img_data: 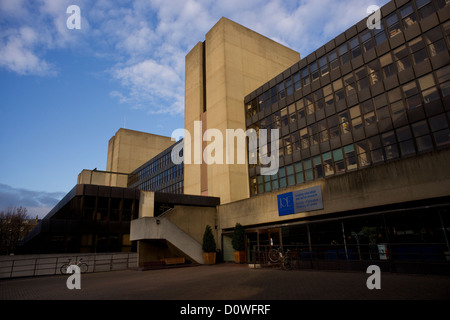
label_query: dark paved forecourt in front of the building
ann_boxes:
[0,264,450,301]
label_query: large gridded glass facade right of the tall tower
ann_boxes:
[245,0,450,195]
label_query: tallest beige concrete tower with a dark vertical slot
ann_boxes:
[184,18,300,203]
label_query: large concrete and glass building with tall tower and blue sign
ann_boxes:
[21,0,450,273]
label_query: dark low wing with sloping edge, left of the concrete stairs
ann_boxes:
[21,184,139,253]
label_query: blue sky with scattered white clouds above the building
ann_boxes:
[0,0,388,217]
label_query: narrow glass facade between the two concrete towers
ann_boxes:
[128,140,184,194]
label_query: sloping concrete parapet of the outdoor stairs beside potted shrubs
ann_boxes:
[130,217,204,264]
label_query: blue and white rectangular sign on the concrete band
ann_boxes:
[277,186,323,216]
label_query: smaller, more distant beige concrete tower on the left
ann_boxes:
[105,128,175,187]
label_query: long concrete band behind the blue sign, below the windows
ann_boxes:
[218,149,450,229]
